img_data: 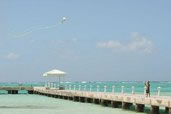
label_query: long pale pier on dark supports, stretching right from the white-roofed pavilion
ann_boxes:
[34,87,171,114]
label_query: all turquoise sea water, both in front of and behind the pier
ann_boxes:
[0,82,171,114]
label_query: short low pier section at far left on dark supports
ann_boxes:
[0,86,33,94]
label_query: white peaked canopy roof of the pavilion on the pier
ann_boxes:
[43,69,66,77]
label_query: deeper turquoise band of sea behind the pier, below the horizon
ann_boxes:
[0,81,171,96]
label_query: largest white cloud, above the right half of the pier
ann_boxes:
[97,32,153,53]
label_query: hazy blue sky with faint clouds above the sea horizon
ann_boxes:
[0,0,171,82]
